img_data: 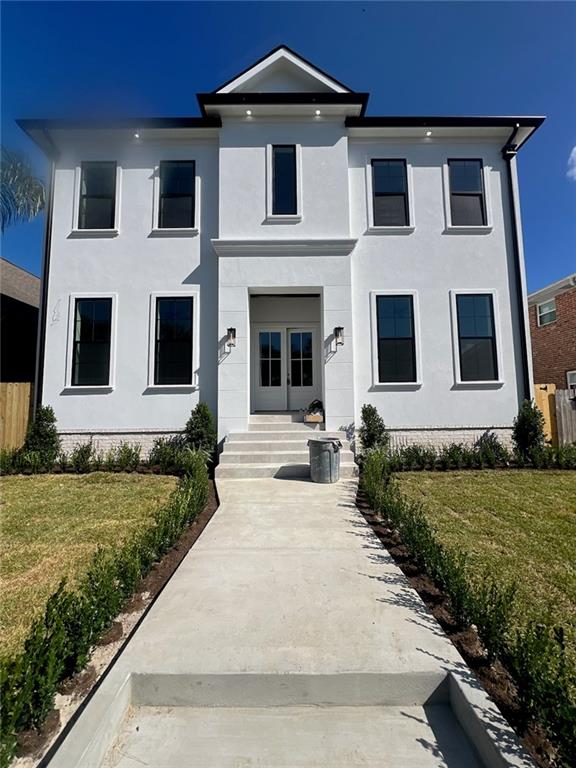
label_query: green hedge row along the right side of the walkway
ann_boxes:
[361,449,576,768]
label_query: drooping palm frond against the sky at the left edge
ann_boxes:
[0,146,46,232]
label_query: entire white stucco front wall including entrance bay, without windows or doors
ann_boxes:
[43,119,523,444]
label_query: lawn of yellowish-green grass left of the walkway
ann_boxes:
[0,472,177,656]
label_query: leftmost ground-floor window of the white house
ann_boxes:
[71,298,112,387]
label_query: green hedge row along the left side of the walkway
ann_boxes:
[0,453,209,768]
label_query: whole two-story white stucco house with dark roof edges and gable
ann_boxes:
[20,46,543,468]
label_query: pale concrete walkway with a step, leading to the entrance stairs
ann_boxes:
[51,479,532,768]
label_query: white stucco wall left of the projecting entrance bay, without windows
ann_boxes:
[43,140,218,443]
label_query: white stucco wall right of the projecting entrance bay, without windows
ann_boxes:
[350,139,523,442]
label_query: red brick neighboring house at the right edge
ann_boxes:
[528,274,576,389]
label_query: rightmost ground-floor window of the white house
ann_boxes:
[456,293,498,382]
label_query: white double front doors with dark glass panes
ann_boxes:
[252,326,321,411]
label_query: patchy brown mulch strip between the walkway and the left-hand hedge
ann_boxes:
[17,481,218,757]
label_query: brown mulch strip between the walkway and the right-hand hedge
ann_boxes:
[356,490,556,768]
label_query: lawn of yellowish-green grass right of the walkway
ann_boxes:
[396,470,576,622]
